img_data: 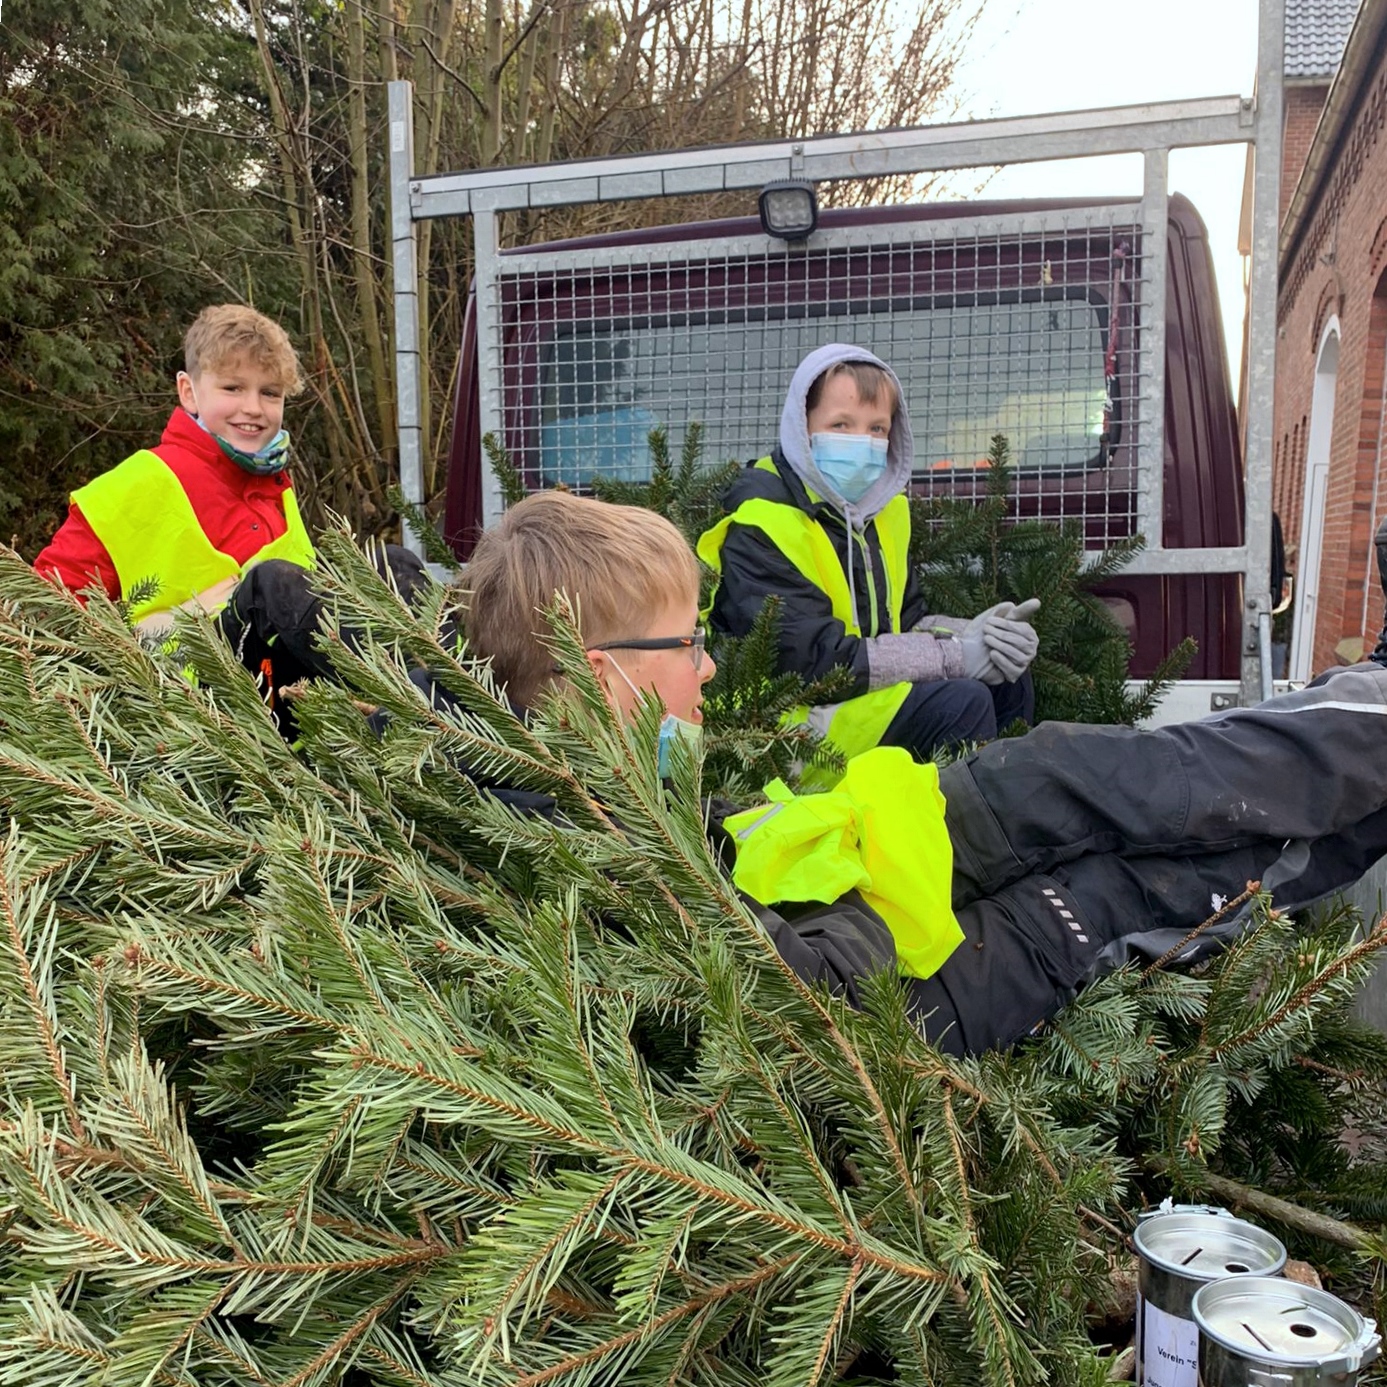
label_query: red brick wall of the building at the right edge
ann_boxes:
[1272,54,1387,669]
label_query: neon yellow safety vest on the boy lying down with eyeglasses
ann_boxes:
[723,746,963,978]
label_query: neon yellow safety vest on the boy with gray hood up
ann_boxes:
[698,458,911,756]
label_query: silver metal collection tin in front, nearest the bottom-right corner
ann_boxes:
[1193,1276,1381,1387]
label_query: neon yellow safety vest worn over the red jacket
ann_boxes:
[72,449,315,623]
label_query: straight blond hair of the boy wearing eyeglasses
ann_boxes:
[463,491,699,707]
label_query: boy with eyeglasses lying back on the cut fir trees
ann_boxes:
[454,492,1387,1054]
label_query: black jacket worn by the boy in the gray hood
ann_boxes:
[709,448,925,694]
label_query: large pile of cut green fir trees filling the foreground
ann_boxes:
[0,507,1387,1387]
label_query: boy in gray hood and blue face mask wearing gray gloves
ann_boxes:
[698,343,1039,760]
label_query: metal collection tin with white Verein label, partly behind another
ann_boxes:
[1133,1200,1286,1387]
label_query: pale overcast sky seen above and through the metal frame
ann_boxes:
[957,0,1257,390]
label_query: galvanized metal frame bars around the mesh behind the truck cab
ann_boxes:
[390,0,1284,703]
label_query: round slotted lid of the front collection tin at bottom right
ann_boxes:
[1194,1276,1381,1372]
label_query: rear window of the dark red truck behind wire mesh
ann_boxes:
[528,284,1108,487]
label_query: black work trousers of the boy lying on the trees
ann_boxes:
[907,664,1387,1053]
